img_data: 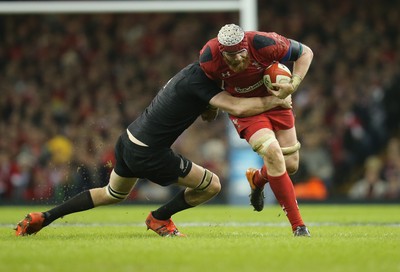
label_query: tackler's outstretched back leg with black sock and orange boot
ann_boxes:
[15,170,137,236]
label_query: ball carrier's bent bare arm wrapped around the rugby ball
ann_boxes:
[272,40,314,98]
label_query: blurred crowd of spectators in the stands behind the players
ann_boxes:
[0,0,400,205]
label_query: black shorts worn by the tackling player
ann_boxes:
[114,131,192,186]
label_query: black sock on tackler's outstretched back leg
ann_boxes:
[43,191,94,226]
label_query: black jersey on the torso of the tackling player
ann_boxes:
[128,62,222,148]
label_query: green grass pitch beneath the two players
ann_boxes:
[0,205,400,272]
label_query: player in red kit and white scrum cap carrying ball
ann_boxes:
[199,24,313,236]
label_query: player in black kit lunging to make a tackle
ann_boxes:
[15,63,291,236]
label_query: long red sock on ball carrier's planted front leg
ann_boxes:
[268,172,304,230]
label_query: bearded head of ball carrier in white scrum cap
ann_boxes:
[217,24,250,72]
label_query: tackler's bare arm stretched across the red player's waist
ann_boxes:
[209,91,292,117]
